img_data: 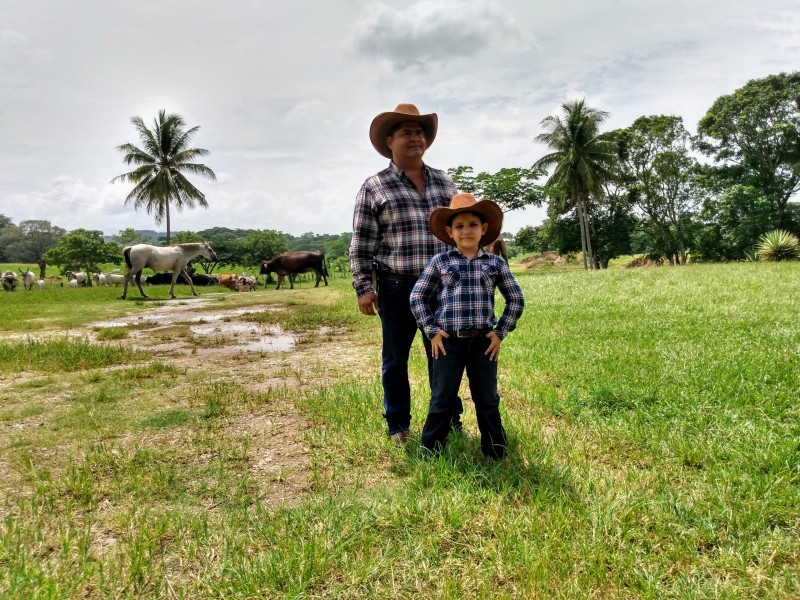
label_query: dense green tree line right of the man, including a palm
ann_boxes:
[500,72,800,268]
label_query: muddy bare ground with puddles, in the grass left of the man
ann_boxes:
[86,300,366,505]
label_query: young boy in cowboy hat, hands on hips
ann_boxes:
[410,194,525,459]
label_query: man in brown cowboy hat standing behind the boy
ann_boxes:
[350,104,463,444]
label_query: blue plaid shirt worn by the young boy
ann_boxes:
[410,248,525,339]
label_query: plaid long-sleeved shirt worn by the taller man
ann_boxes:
[350,163,457,296]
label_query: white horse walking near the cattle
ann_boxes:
[120,242,218,300]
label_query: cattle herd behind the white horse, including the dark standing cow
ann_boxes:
[0,251,328,292]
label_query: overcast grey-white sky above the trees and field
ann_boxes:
[0,0,800,235]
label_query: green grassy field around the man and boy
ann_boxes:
[0,263,800,599]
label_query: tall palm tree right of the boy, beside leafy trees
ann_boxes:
[531,100,617,269]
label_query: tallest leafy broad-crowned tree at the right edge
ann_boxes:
[697,71,800,225]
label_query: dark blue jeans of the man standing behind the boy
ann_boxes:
[378,280,464,435]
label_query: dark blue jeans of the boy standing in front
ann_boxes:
[422,335,506,458]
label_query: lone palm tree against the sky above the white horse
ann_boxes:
[111,109,217,246]
